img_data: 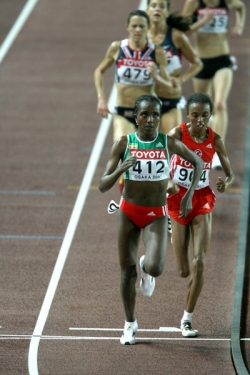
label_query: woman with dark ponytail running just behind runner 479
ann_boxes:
[147,0,206,134]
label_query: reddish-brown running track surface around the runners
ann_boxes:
[0,0,250,375]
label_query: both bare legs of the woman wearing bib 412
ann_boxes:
[117,210,167,322]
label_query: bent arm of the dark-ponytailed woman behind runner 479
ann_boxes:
[173,29,203,83]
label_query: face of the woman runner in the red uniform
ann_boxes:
[187,103,212,132]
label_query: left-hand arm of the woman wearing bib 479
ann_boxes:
[94,42,120,118]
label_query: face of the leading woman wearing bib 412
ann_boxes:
[135,101,161,138]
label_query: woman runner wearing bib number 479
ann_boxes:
[94,10,176,193]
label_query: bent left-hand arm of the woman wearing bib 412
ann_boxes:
[99,135,136,193]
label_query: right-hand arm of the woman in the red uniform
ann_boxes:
[214,133,235,193]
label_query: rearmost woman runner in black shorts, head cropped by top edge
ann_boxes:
[183,0,246,169]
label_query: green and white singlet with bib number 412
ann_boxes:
[123,132,170,181]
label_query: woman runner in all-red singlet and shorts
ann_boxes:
[167,93,234,337]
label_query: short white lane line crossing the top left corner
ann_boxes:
[0,0,38,64]
